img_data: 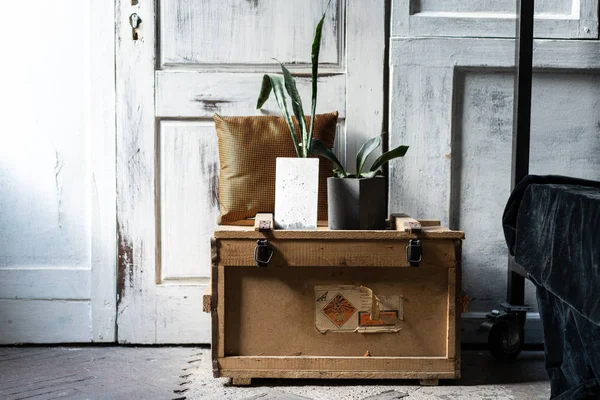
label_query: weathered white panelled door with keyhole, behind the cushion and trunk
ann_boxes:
[116,0,386,343]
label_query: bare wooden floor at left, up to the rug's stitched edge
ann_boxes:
[0,347,201,400]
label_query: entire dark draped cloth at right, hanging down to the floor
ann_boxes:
[502,175,600,399]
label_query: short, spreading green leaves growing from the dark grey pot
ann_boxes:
[311,136,408,178]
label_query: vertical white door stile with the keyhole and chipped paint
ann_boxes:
[115,0,159,343]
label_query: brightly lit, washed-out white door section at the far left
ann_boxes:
[0,0,115,343]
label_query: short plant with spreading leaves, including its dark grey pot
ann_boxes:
[311,136,408,229]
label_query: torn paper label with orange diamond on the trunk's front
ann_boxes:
[315,285,404,333]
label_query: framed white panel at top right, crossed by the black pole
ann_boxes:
[392,0,598,39]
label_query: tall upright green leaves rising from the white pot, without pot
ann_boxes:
[256,0,331,158]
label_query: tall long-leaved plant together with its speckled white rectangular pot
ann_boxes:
[256,1,331,229]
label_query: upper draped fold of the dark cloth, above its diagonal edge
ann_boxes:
[502,175,600,325]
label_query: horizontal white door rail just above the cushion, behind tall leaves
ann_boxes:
[156,71,346,119]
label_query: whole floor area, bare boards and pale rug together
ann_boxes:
[0,346,550,400]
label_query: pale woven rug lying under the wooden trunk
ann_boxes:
[183,349,550,400]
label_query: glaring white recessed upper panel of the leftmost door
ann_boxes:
[0,1,90,267]
